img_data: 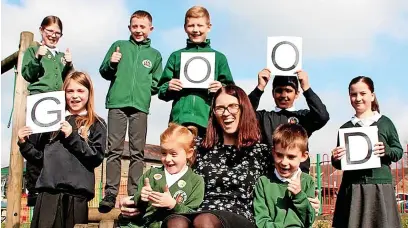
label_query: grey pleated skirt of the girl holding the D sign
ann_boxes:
[333,184,401,228]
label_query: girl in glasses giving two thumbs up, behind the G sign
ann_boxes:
[21,16,73,206]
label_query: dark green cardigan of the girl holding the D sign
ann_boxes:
[332,115,403,185]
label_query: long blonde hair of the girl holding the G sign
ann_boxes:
[62,71,99,141]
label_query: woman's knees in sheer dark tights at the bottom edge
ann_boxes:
[166,213,222,228]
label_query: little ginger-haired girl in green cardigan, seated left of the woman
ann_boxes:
[119,123,204,227]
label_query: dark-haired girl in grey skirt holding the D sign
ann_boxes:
[332,76,403,228]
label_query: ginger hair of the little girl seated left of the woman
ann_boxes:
[160,123,198,165]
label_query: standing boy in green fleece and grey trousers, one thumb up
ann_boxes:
[99,10,162,213]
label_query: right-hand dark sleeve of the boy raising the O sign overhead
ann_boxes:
[302,88,330,134]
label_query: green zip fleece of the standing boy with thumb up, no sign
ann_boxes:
[99,37,162,113]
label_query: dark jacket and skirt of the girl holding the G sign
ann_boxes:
[18,115,106,228]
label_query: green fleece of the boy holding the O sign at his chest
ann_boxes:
[158,39,234,128]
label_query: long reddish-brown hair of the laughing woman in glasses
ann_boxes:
[202,85,261,149]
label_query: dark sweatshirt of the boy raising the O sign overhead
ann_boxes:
[248,87,330,173]
